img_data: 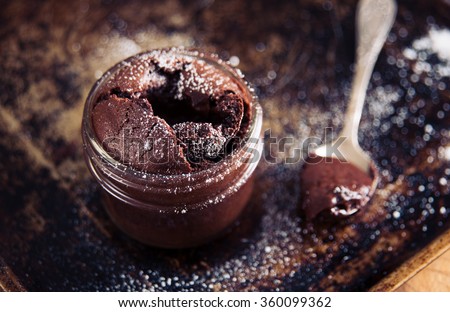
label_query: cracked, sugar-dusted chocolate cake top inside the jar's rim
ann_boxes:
[92,50,250,175]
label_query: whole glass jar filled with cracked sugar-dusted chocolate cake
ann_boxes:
[82,48,262,248]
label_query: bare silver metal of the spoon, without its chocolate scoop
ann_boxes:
[314,0,397,173]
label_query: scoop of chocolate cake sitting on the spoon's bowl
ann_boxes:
[300,156,376,220]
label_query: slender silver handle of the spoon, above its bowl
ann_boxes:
[341,0,397,143]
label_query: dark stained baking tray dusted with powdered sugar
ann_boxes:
[0,0,450,291]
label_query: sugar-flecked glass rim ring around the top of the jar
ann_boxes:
[82,47,262,187]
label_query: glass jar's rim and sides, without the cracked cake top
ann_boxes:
[82,49,262,248]
